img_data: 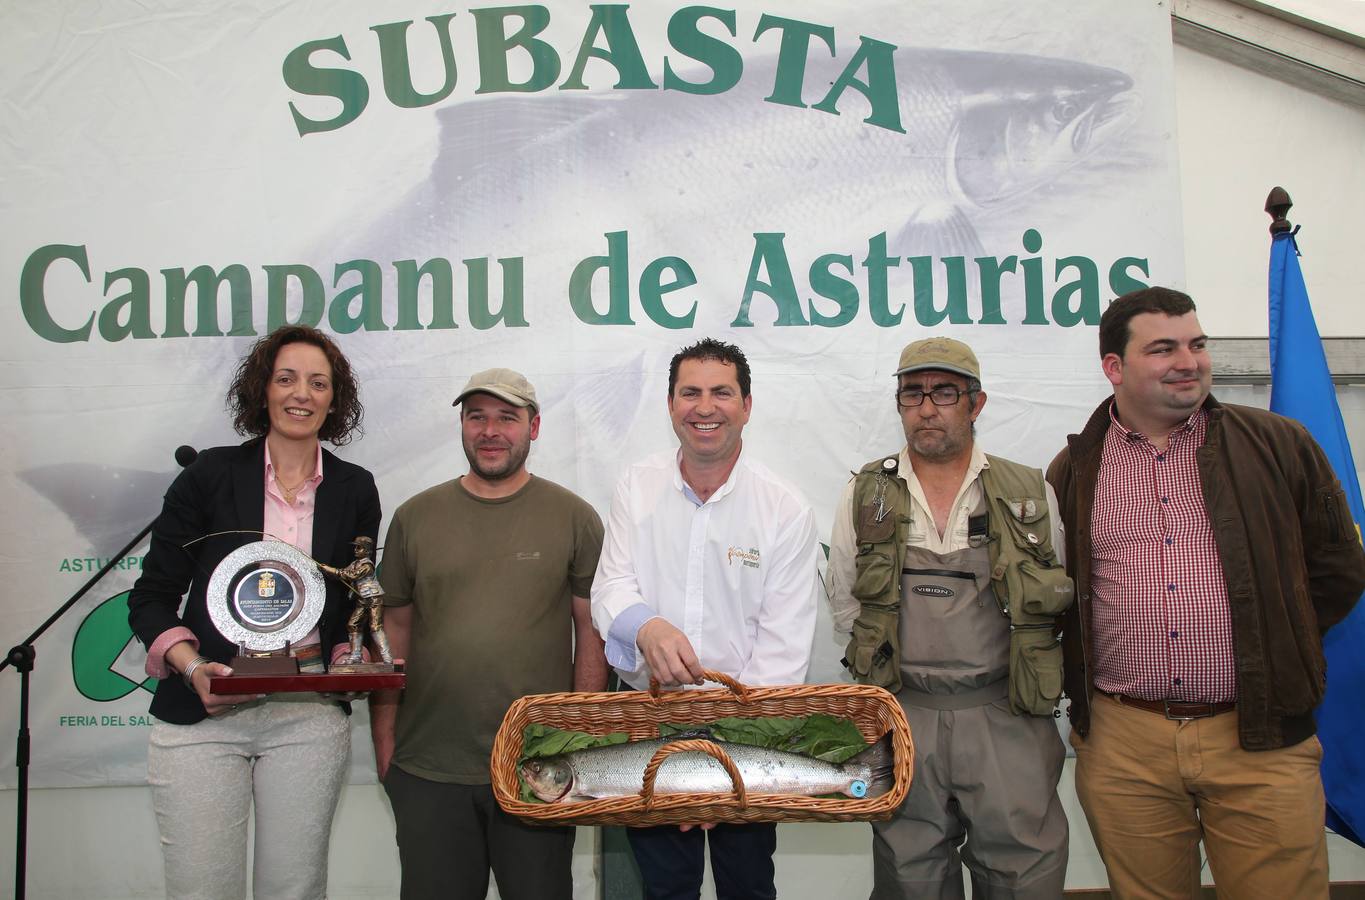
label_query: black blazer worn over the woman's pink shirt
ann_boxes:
[128,438,381,725]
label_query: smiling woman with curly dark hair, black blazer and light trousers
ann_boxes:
[128,325,381,900]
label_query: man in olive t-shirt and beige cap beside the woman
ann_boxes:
[370,369,606,900]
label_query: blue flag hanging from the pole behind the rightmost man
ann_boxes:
[1269,228,1365,847]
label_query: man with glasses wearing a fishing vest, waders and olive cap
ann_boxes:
[829,337,1073,900]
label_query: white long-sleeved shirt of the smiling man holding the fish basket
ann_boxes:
[592,449,819,690]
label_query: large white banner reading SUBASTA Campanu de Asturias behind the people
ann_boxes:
[0,0,1183,785]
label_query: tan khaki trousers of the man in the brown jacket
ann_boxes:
[1072,691,1327,900]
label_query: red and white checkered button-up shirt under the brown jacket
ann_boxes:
[1091,406,1237,703]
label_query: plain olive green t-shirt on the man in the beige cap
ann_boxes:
[379,475,602,784]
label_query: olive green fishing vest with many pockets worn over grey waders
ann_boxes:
[844,456,1074,716]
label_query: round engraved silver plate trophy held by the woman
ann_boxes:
[206,541,328,675]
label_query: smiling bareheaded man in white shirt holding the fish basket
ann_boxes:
[592,339,818,900]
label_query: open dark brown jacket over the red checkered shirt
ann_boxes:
[1047,396,1365,750]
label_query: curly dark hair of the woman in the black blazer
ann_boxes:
[228,325,364,447]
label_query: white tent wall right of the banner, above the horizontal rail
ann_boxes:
[1175,37,1365,337]
